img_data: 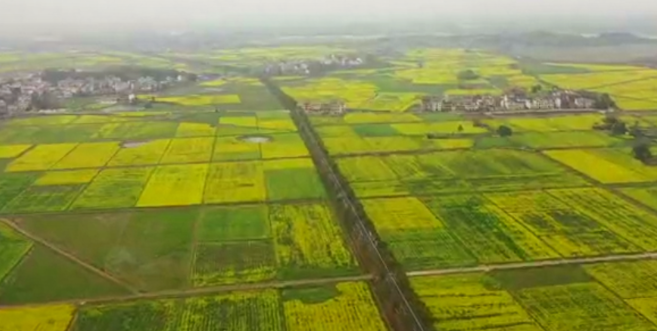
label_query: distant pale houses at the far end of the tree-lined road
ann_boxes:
[263,54,365,76]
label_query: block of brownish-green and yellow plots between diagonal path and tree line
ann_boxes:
[11,202,359,296]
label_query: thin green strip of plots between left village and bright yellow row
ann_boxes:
[0,111,296,145]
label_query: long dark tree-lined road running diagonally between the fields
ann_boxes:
[261,78,435,331]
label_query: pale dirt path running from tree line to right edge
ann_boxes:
[406,253,657,277]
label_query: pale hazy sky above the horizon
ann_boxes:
[0,0,657,27]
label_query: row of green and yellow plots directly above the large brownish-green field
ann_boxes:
[0,159,324,212]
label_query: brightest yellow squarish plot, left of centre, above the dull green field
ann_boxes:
[137,164,208,207]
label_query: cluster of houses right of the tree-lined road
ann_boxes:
[421,89,596,112]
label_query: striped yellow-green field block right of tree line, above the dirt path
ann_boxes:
[362,188,657,269]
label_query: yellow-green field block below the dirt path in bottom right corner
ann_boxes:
[411,261,657,331]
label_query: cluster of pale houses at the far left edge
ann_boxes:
[0,73,184,115]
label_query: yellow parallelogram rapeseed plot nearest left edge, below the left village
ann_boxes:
[6,144,77,171]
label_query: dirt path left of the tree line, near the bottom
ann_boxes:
[0,275,372,309]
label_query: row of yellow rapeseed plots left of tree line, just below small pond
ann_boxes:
[2,133,308,172]
